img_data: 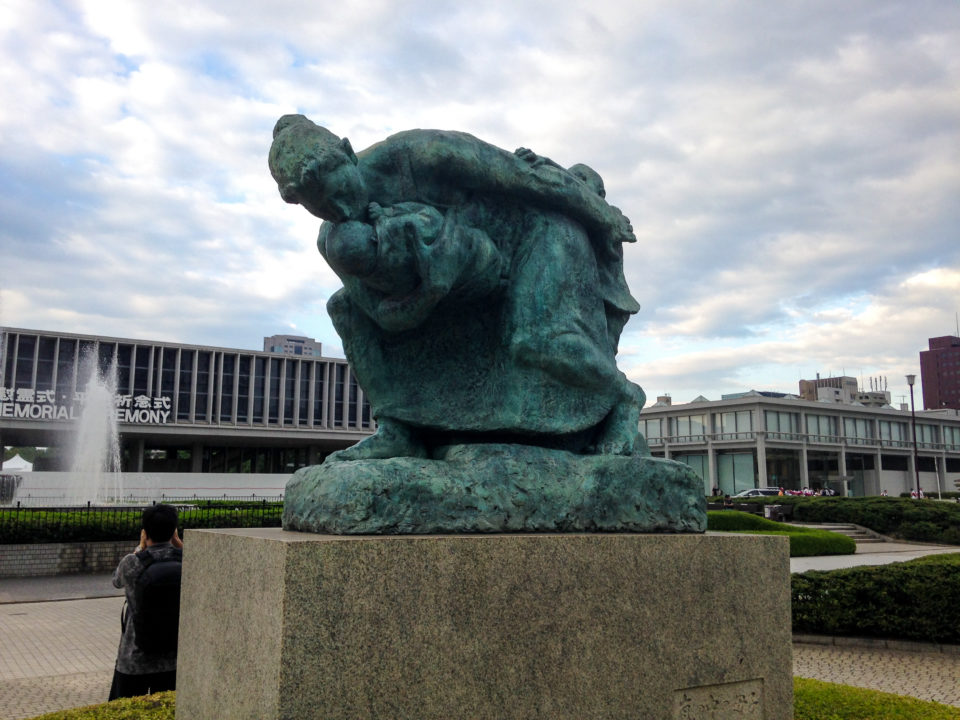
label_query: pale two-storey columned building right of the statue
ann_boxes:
[640,393,960,496]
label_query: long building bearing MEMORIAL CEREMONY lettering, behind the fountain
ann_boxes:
[0,327,375,500]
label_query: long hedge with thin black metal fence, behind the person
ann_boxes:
[0,496,283,544]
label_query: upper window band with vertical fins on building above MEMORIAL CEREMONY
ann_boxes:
[0,333,372,428]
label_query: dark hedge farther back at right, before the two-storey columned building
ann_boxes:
[728,496,960,545]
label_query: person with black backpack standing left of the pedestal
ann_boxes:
[109,504,183,700]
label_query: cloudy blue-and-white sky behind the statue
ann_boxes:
[0,0,960,402]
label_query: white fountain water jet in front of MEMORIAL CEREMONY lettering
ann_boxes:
[65,352,123,505]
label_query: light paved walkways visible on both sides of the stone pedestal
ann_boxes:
[0,543,960,720]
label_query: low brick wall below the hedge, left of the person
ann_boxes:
[0,540,136,578]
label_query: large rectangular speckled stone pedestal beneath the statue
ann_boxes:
[177,530,793,720]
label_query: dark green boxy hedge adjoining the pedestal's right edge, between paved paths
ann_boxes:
[791,553,960,644]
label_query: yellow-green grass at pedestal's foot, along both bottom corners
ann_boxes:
[24,678,960,720]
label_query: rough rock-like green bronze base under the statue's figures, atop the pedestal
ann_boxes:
[283,444,706,535]
